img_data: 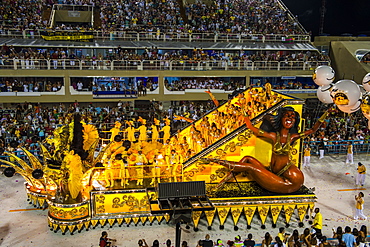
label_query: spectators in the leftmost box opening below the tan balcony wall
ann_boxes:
[0,77,64,92]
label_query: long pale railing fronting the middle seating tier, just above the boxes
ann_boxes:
[0,58,330,71]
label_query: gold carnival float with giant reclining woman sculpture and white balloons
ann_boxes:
[0,66,370,234]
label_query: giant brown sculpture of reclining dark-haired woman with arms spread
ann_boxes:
[203,107,329,193]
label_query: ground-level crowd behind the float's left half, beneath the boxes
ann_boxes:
[0,101,213,151]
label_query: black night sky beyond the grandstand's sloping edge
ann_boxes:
[282,0,370,36]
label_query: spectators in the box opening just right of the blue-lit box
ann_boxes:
[164,77,245,91]
